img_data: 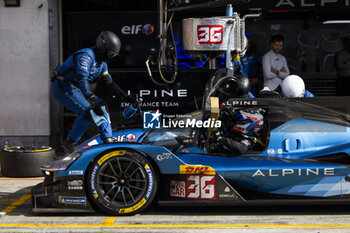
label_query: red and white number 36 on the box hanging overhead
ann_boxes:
[197,25,223,44]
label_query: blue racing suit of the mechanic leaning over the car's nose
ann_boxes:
[52,47,113,141]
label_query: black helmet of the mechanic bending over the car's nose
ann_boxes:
[96,31,121,60]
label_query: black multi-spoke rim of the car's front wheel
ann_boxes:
[96,157,148,208]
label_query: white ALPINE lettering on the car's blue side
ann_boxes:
[252,168,335,177]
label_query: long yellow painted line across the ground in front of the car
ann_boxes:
[0,224,350,228]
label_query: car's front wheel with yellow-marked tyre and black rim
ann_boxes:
[87,149,158,215]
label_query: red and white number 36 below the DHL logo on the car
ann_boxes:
[186,175,215,200]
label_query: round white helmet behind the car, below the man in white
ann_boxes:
[281,75,305,98]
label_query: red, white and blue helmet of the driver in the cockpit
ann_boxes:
[232,108,264,135]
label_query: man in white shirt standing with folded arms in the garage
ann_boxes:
[262,35,289,91]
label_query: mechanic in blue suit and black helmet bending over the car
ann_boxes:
[50,31,136,152]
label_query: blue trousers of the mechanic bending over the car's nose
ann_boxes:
[52,80,112,142]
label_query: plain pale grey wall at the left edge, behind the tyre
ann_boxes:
[0,0,59,148]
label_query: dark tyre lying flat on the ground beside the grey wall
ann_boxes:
[0,146,55,178]
